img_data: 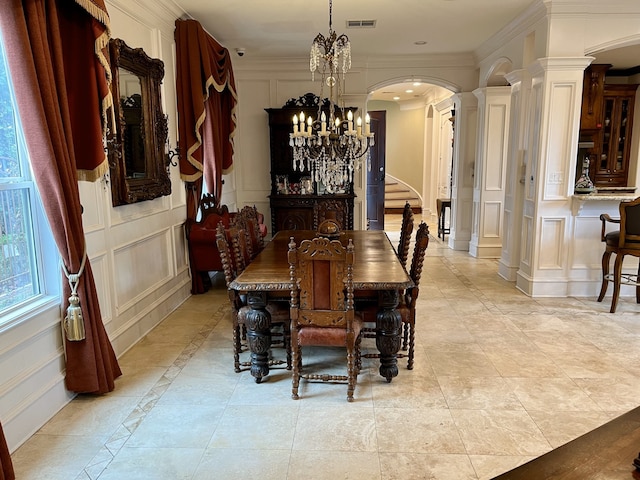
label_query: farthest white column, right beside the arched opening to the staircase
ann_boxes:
[448,92,478,251]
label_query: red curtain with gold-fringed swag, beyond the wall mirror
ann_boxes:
[175,20,237,219]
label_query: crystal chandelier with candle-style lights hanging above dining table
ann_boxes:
[289,0,374,193]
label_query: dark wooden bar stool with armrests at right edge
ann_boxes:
[598,197,640,313]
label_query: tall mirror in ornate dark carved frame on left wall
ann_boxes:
[107,38,171,206]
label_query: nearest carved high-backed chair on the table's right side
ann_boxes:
[358,222,429,370]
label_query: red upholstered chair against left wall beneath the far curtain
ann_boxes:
[185,202,231,294]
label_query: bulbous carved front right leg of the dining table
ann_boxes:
[376,290,402,382]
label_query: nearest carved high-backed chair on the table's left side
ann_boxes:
[216,224,291,373]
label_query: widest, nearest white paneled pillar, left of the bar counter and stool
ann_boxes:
[516,57,592,297]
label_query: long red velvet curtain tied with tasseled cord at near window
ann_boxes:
[0,0,122,402]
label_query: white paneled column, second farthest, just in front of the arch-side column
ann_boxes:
[469,87,511,258]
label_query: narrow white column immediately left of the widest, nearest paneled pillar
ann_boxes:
[498,70,531,281]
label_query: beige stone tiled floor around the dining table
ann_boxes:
[8,216,640,480]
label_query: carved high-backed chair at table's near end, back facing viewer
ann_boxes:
[288,237,362,402]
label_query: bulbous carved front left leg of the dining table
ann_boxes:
[246,292,271,383]
